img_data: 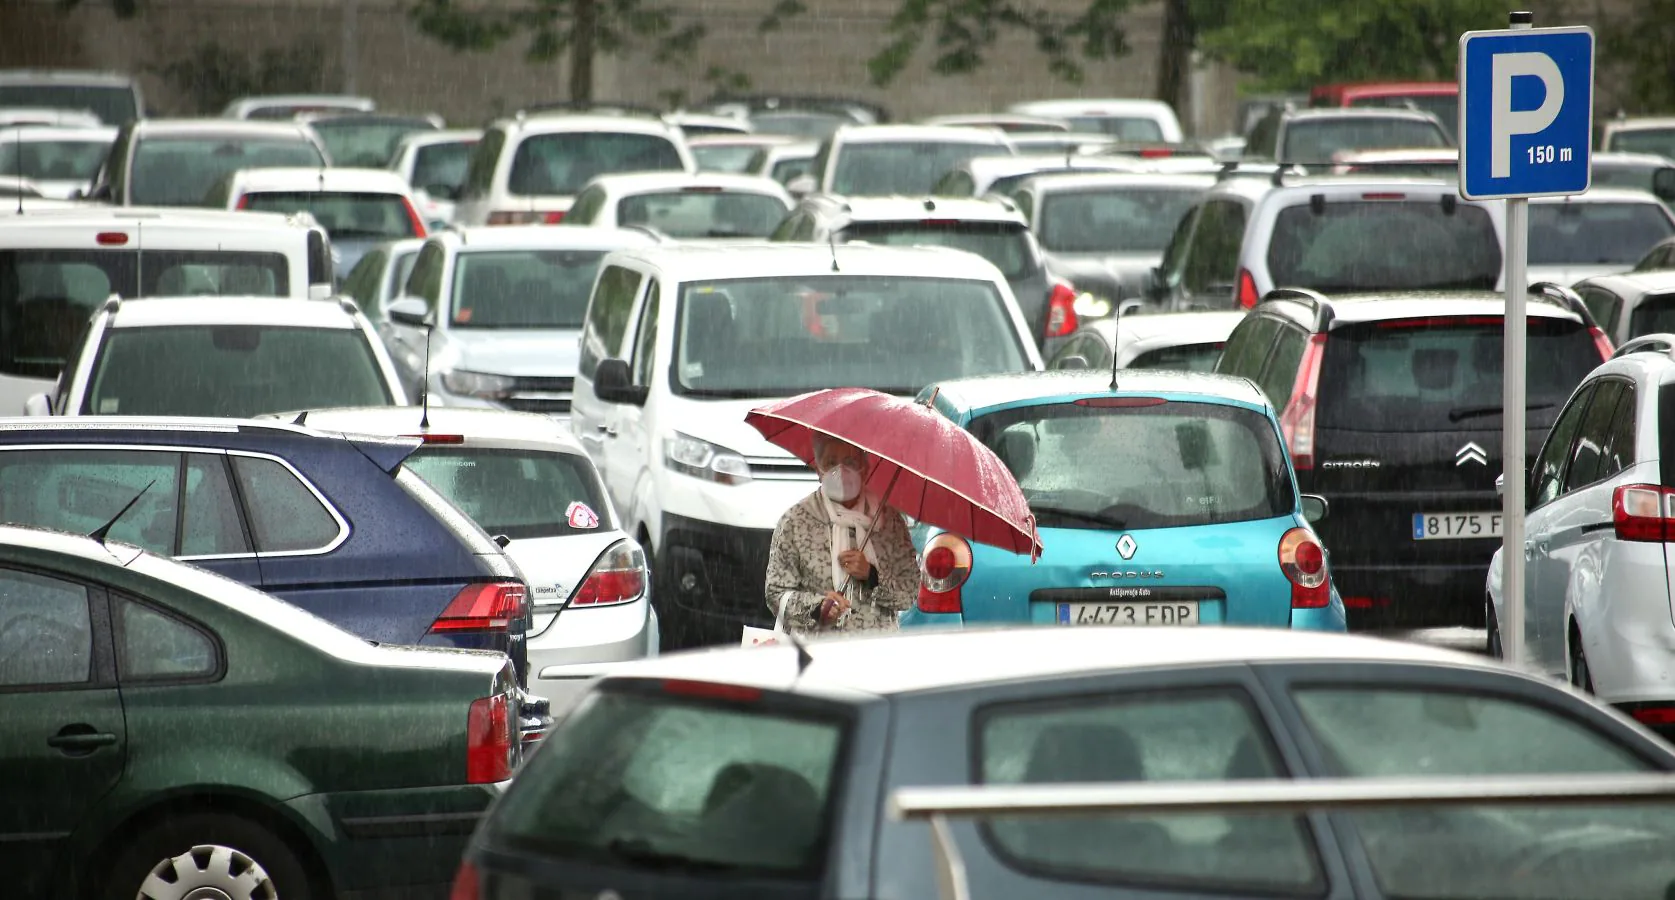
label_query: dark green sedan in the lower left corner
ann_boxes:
[0,528,518,900]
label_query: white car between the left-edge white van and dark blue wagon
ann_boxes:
[23,297,407,419]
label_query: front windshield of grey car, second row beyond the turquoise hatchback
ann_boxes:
[1035,188,1203,253]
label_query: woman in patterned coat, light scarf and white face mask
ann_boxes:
[765,432,920,632]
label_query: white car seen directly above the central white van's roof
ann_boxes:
[561,173,791,240]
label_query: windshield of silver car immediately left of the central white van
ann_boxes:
[452,250,605,328]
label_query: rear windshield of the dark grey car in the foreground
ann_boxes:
[484,689,846,880]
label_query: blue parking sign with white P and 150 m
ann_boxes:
[1459,27,1593,199]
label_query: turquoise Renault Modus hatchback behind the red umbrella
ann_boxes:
[901,370,1345,632]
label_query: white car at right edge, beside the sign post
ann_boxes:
[1487,334,1675,737]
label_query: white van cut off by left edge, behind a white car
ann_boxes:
[0,206,332,412]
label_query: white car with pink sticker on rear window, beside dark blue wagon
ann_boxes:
[261,406,658,709]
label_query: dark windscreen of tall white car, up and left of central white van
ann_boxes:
[506,131,685,196]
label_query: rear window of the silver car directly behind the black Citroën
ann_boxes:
[1268,201,1507,292]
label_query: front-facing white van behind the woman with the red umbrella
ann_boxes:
[571,243,1042,650]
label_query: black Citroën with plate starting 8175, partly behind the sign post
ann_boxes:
[1216,285,1611,628]
